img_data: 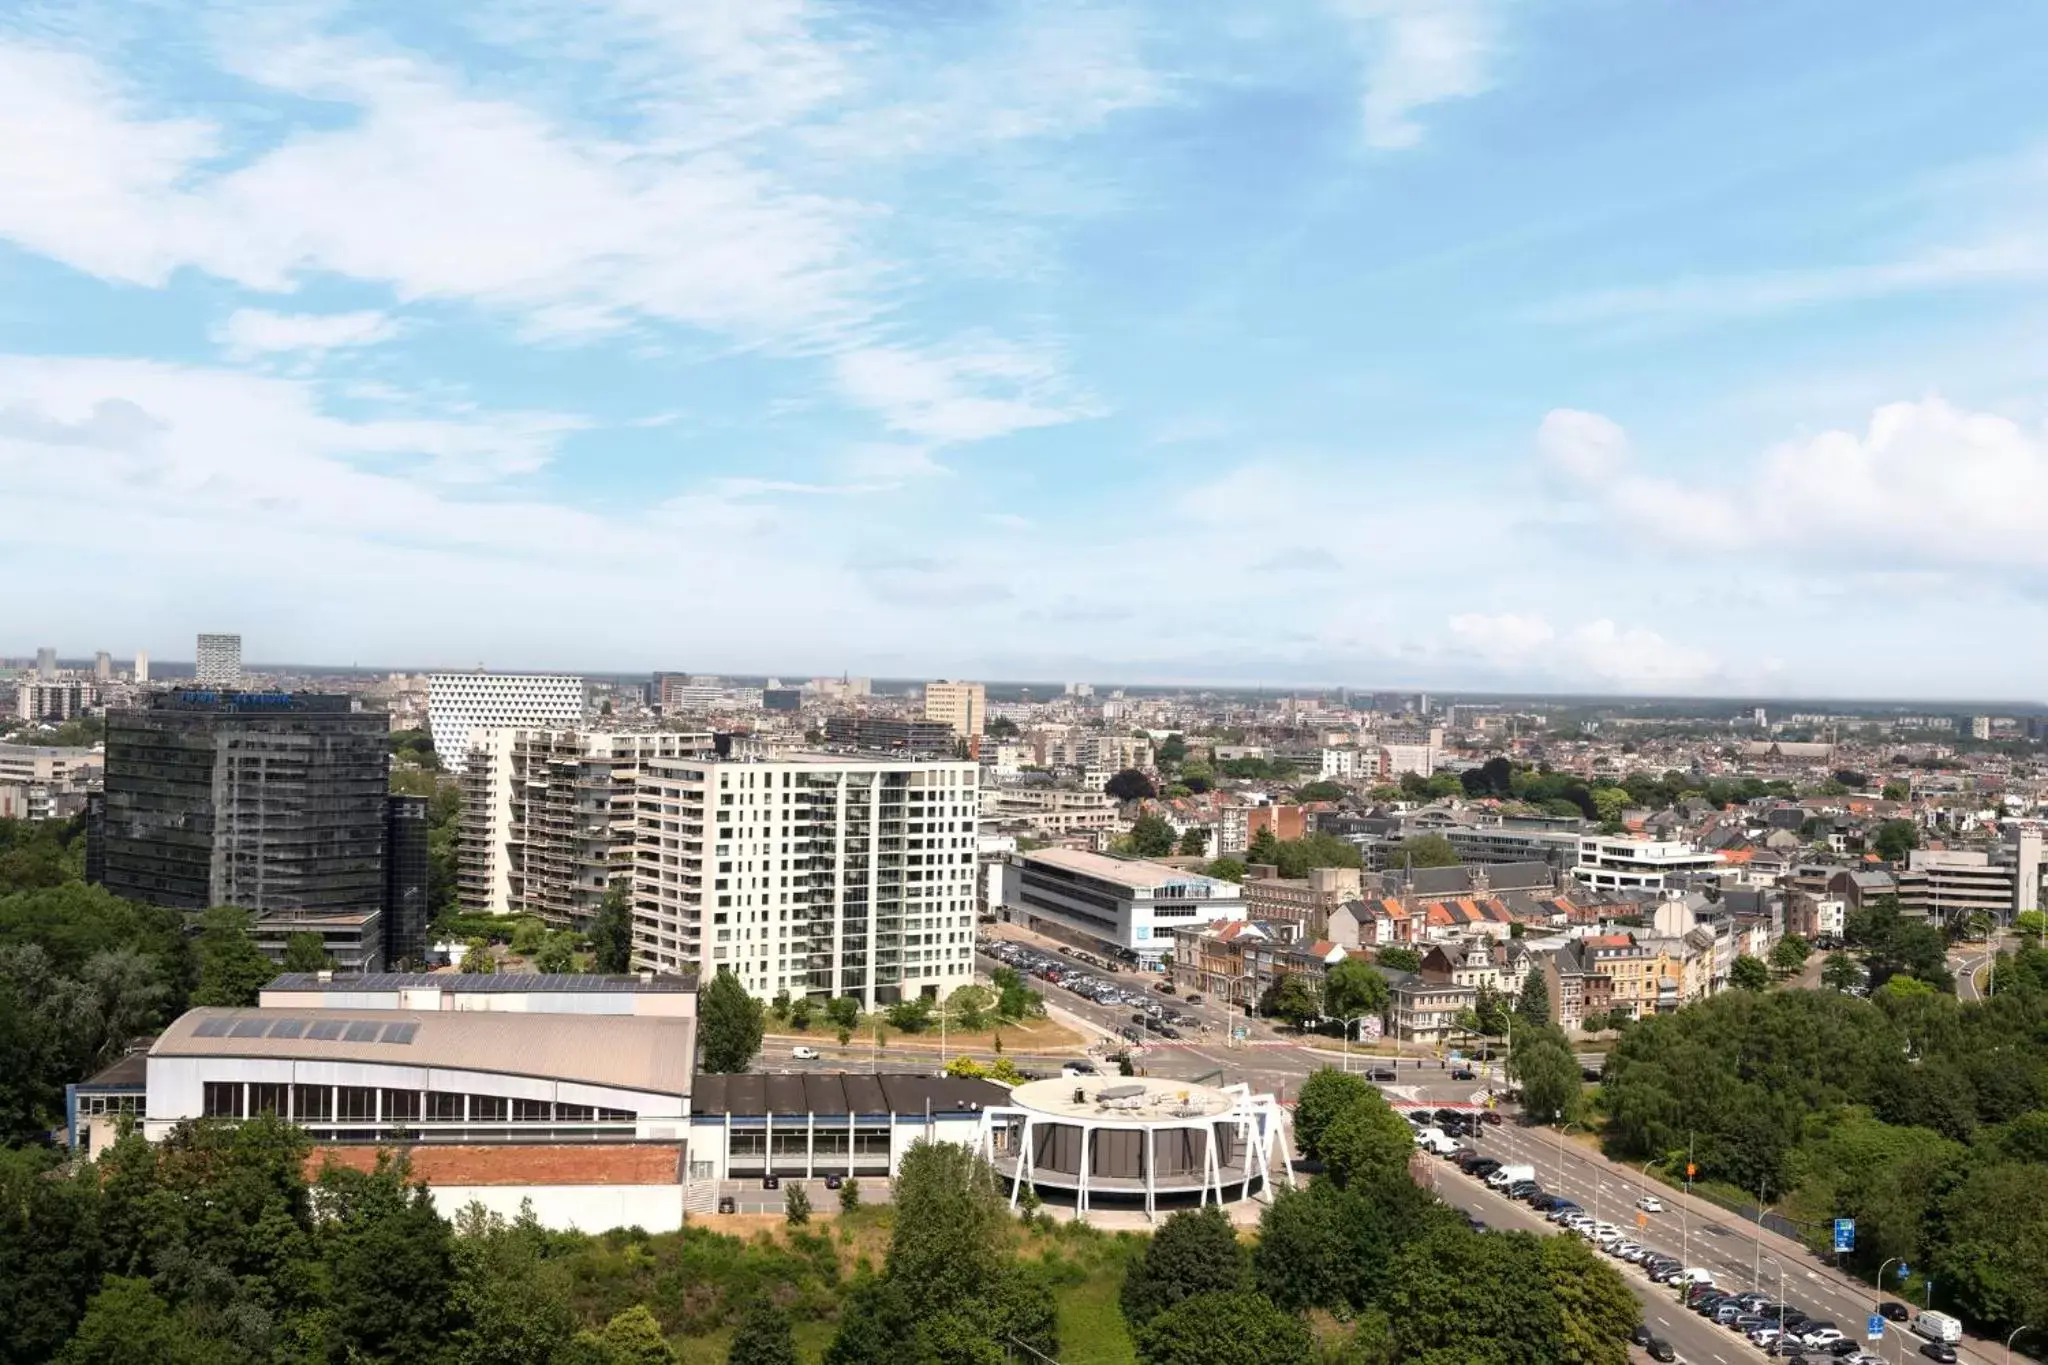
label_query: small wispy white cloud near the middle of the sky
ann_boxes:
[834,338,1100,442]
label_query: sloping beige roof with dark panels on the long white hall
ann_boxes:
[150,1007,696,1095]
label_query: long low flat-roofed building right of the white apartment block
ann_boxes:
[1001,849,1245,962]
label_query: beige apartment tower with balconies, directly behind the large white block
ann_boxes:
[455,729,713,929]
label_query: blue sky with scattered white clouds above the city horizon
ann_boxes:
[0,0,2048,700]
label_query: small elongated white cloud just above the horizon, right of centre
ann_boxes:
[1446,612,1720,690]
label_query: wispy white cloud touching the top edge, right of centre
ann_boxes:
[1331,0,1495,149]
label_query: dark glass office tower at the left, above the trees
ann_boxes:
[100,690,389,915]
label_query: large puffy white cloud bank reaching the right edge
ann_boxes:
[1538,397,2048,569]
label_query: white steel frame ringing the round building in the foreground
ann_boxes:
[981,1085,1294,1222]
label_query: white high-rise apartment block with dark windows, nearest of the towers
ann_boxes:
[633,755,979,1009]
